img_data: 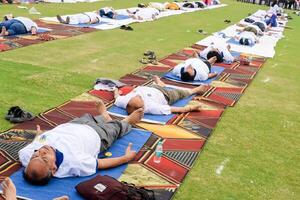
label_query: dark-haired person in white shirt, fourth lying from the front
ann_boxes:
[199,42,235,63]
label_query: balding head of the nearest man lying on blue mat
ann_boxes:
[23,145,57,185]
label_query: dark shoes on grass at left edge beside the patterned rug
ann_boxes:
[5,106,34,123]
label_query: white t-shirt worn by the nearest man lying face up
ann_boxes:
[19,123,101,178]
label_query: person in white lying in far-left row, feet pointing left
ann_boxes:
[56,12,101,25]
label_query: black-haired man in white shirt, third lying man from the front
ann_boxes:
[172,56,218,82]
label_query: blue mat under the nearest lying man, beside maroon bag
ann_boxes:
[11,129,151,200]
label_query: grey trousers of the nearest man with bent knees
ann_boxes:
[70,114,132,152]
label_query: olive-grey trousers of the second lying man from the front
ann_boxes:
[150,85,191,105]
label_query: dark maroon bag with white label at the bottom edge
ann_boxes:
[75,175,155,200]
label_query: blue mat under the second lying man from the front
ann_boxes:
[108,96,194,124]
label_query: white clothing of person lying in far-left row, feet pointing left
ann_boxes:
[69,12,101,25]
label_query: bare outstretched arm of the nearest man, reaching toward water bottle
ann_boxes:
[97,143,136,169]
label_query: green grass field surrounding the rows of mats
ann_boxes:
[0,0,300,200]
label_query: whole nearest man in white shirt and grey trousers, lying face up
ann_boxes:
[19,101,143,185]
